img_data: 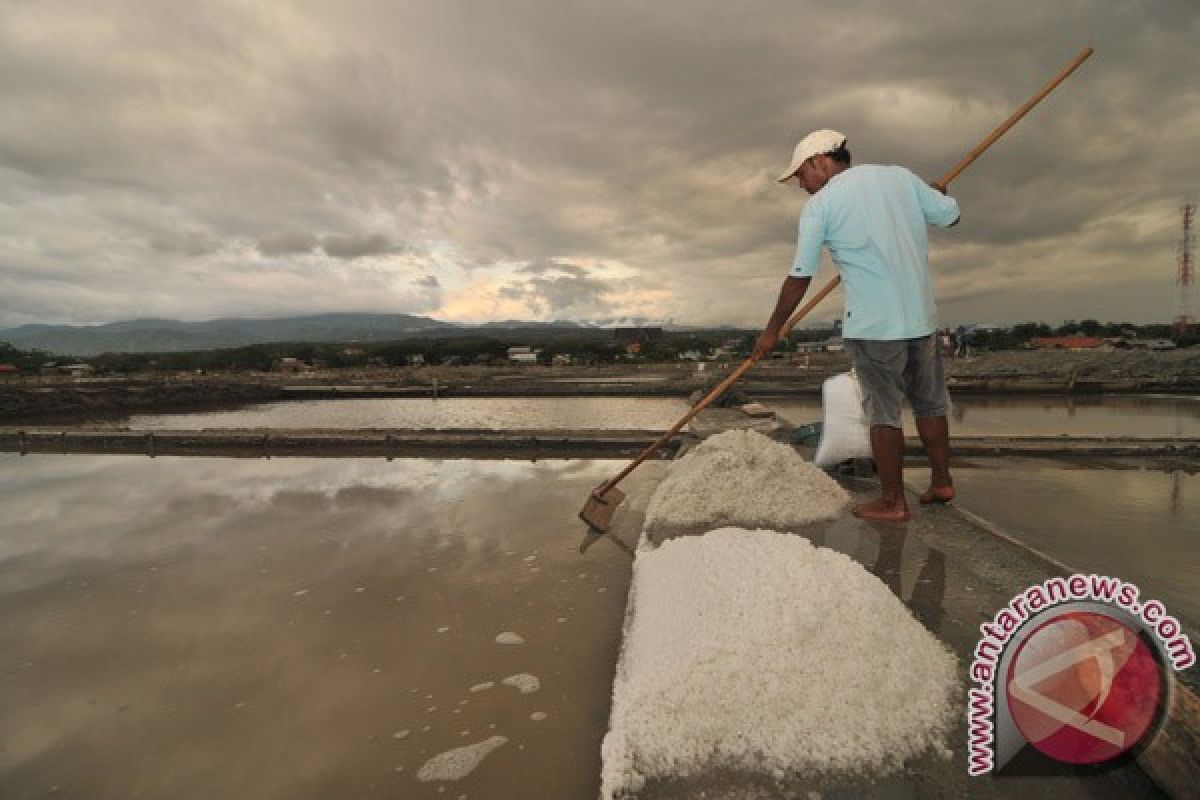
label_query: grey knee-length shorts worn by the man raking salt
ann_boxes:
[845,333,950,428]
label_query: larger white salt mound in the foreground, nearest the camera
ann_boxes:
[601,528,958,798]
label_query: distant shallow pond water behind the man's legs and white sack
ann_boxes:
[764,395,1200,437]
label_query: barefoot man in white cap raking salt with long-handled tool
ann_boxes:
[755,130,959,522]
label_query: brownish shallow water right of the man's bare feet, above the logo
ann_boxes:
[905,458,1200,624]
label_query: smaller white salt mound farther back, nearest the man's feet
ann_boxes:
[646,431,850,529]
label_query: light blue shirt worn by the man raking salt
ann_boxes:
[790,164,959,339]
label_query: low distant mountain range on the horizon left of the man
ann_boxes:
[0,313,705,356]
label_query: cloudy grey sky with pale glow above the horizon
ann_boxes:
[0,0,1200,326]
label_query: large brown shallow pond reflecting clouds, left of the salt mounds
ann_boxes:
[0,456,661,800]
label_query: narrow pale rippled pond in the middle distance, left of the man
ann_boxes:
[128,397,688,431]
